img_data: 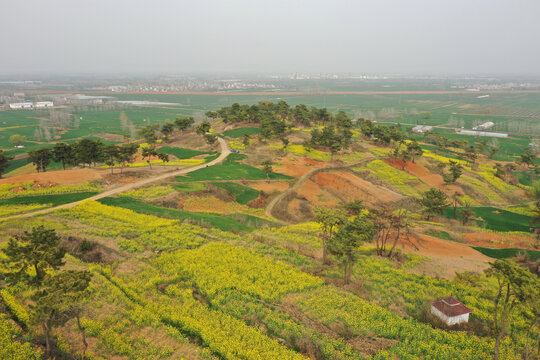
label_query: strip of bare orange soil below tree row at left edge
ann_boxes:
[0,169,108,185]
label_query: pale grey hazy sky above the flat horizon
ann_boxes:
[0,0,540,75]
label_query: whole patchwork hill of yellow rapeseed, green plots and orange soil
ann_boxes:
[0,102,540,359]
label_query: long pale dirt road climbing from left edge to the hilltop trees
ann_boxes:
[0,137,231,221]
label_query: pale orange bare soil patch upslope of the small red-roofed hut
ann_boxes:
[398,233,492,279]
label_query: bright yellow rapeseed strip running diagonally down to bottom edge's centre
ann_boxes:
[92,264,306,360]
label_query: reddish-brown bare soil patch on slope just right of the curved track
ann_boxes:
[314,170,402,206]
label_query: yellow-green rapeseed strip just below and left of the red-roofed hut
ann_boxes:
[295,287,517,360]
